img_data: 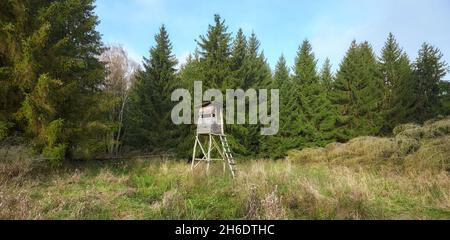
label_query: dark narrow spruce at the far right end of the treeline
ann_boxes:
[414,43,448,122]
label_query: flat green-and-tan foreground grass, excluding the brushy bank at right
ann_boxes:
[0,157,450,219]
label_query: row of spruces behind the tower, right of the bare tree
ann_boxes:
[128,15,450,158]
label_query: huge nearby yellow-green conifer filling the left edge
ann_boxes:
[0,0,108,164]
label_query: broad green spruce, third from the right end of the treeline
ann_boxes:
[331,41,383,141]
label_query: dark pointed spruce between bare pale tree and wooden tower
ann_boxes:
[126,25,177,151]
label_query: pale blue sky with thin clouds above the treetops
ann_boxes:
[95,0,450,76]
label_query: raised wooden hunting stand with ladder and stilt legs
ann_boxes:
[191,102,236,178]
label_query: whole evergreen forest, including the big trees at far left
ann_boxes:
[0,0,450,165]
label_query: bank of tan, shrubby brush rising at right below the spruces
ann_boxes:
[288,118,450,171]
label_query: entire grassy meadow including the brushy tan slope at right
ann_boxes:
[0,119,450,219]
